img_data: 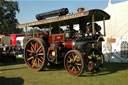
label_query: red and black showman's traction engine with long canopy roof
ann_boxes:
[17,8,110,76]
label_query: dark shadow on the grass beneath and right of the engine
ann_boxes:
[44,62,128,77]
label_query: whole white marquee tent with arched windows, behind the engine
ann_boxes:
[102,0,128,63]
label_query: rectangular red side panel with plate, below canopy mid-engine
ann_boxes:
[48,34,64,43]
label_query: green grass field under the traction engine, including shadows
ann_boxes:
[0,58,128,85]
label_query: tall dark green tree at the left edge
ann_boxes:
[0,0,23,35]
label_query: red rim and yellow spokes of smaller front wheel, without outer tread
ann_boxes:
[65,52,83,76]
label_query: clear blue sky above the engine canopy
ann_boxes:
[12,0,127,24]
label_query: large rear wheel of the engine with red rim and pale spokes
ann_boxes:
[25,39,45,71]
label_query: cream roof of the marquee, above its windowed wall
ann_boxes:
[104,0,128,37]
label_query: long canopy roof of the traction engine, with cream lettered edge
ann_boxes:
[16,9,110,28]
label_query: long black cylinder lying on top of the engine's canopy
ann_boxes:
[36,8,69,20]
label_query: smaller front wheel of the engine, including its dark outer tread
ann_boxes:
[64,50,85,76]
